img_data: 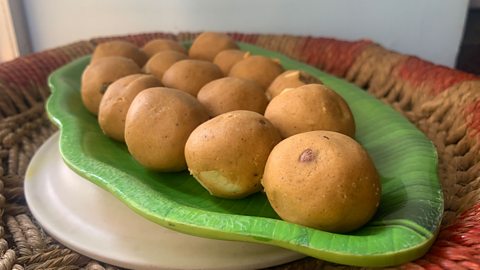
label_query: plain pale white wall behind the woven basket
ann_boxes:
[23,0,469,66]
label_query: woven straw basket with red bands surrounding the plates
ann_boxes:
[0,33,480,270]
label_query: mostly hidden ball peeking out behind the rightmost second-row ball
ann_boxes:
[265,70,322,100]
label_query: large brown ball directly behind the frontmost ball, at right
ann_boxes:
[265,84,355,138]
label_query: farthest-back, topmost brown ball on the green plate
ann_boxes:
[188,32,238,61]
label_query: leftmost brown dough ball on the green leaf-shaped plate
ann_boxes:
[80,56,142,115]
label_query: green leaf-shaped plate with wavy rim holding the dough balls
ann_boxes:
[47,44,443,266]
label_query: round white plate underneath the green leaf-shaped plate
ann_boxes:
[25,133,305,269]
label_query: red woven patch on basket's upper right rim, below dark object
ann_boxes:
[394,57,476,95]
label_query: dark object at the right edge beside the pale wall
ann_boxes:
[456,9,480,75]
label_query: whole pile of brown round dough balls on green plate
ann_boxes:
[81,32,381,232]
